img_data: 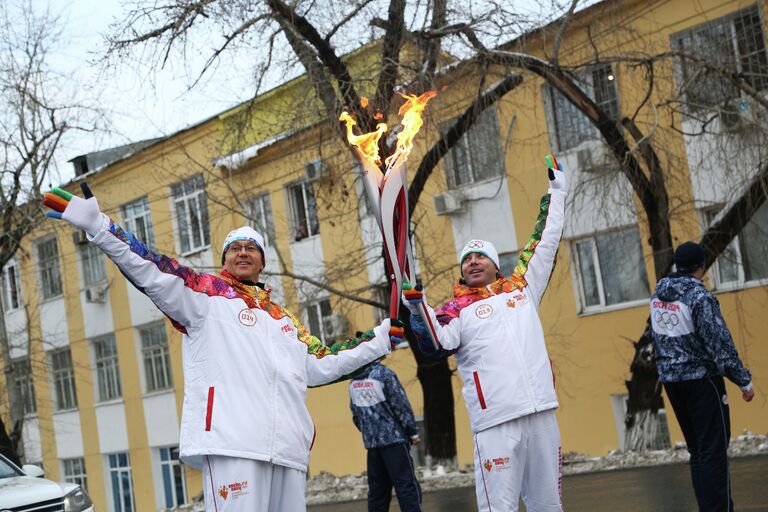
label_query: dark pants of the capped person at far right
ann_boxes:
[664,377,733,512]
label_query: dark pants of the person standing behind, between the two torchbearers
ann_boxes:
[368,443,421,512]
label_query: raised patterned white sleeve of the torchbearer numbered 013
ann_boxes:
[510,190,566,307]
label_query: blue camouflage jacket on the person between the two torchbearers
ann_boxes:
[349,363,419,449]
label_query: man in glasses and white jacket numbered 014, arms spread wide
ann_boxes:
[44,184,390,512]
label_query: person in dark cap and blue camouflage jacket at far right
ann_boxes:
[650,242,755,512]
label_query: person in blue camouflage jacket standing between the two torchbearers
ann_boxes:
[349,361,421,512]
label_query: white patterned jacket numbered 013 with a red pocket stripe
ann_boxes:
[411,190,566,433]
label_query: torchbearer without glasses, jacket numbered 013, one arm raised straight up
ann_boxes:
[404,165,566,512]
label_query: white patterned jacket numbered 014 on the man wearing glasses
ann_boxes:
[92,216,390,471]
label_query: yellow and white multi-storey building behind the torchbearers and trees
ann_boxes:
[0,0,768,512]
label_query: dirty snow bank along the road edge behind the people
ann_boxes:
[167,430,768,512]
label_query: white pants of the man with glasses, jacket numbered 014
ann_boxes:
[203,455,307,512]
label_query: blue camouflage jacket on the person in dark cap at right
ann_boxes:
[650,274,752,388]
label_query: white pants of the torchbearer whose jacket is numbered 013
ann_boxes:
[475,409,563,512]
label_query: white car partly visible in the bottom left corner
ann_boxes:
[0,455,94,512]
